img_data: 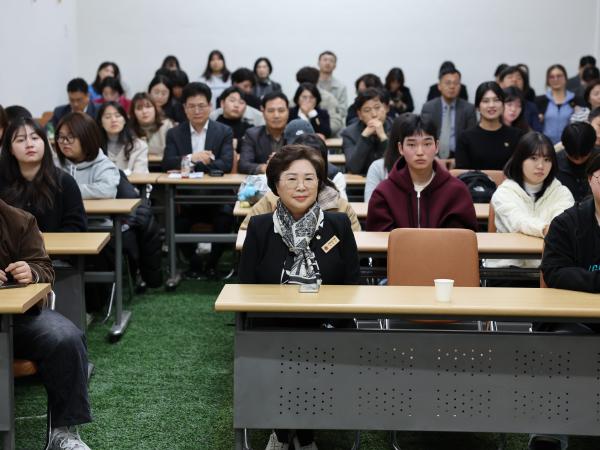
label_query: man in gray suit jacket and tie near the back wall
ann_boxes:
[421,68,477,159]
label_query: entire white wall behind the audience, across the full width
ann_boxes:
[0,0,600,116]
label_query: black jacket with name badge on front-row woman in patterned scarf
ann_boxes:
[239,212,360,284]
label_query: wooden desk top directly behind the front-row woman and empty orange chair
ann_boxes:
[235,230,544,256]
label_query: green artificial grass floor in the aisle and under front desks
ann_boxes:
[15,281,600,450]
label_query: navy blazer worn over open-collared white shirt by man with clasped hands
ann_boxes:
[162,120,233,173]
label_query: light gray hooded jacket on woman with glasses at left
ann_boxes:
[61,150,120,200]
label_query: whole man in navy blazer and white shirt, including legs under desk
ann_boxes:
[162,82,233,278]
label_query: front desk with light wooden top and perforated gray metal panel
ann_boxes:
[216,285,600,440]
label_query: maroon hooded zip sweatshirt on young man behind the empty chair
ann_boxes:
[366,158,477,231]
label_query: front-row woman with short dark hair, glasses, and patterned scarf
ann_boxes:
[239,145,359,450]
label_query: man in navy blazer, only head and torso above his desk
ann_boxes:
[162,82,233,173]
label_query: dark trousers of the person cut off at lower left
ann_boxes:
[13,309,92,427]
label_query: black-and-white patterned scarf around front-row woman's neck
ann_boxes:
[273,200,324,285]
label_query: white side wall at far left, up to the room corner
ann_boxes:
[0,0,77,116]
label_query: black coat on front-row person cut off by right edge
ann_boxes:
[541,198,600,292]
